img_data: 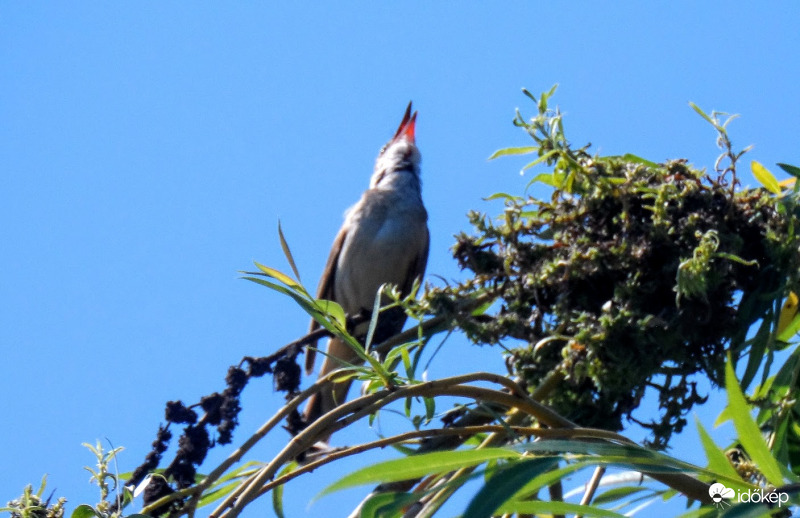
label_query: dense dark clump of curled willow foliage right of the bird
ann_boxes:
[446,87,800,448]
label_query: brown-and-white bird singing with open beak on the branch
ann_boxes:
[304,103,430,432]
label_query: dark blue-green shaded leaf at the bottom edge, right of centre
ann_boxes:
[463,457,559,518]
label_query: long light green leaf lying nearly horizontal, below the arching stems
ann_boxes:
[319,448,520,496]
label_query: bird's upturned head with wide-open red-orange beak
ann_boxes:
[369,103,422,188]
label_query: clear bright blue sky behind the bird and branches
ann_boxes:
[0,1,800,516]
